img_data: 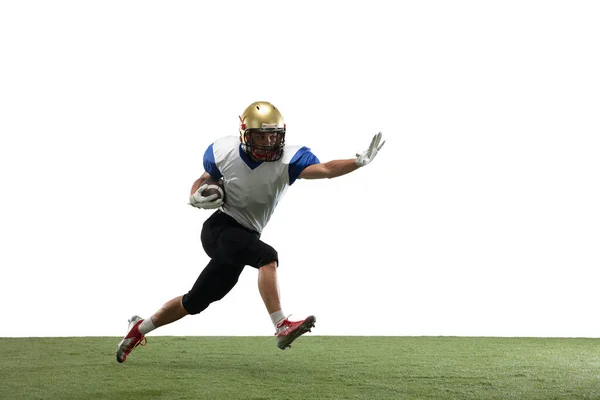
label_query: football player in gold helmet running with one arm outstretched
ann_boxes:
[117,101,385,363]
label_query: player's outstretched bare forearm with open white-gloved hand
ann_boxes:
[299,132,385,179]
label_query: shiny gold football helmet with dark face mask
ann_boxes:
[240,101,285,161]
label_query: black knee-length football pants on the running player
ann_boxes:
[182,210,279,314]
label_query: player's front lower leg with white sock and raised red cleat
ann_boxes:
[258,261,316,350]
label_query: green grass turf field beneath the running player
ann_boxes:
[0,336,600,400]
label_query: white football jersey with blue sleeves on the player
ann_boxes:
[204,136,319,233]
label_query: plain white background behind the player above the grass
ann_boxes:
[0,1,600,337]
